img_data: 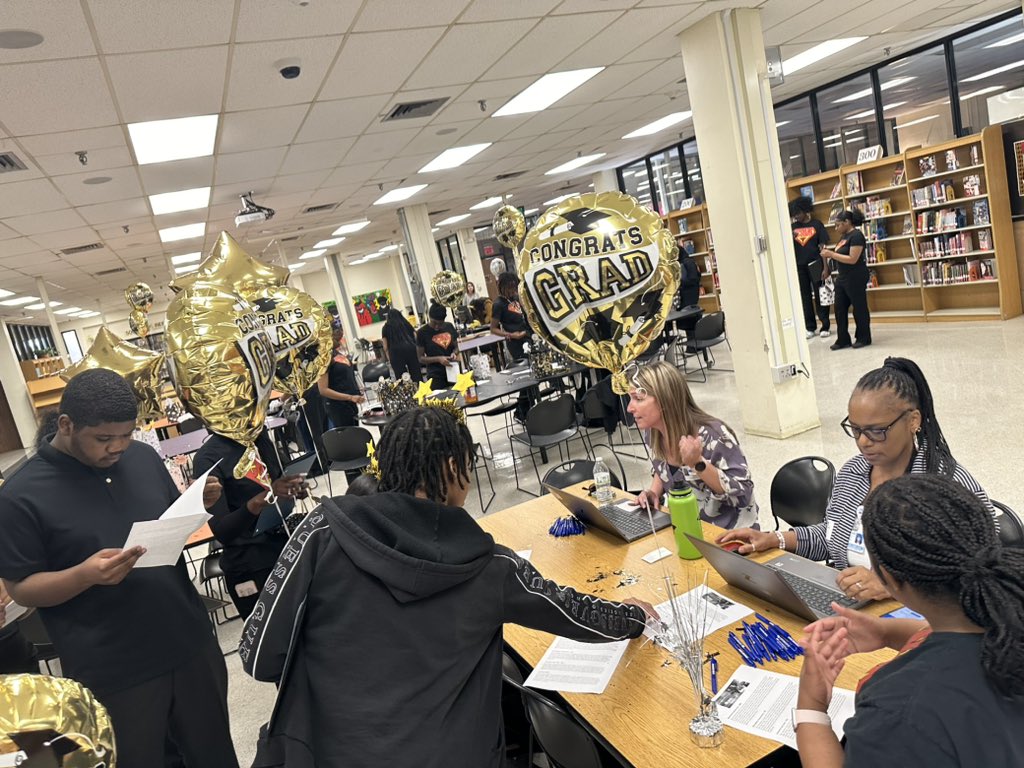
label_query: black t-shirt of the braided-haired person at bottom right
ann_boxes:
[843,632,1024,768]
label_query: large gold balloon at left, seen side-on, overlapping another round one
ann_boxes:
[164,283,276,477]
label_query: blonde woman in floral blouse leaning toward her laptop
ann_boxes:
[627,361,758,528]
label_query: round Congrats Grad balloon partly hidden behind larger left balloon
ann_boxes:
[246,286,334,397]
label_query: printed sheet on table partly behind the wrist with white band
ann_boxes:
[715,665,854,750]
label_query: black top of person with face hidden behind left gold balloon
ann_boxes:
[193,429,295,581]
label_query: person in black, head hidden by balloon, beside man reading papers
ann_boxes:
[193,428,302,618]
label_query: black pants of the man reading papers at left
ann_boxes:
[99,636,239,768]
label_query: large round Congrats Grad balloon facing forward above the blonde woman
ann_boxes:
[518,191,679,394]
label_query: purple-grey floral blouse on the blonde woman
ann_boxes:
[644,420,760,528]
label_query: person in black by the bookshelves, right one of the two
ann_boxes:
[821,210,871,350]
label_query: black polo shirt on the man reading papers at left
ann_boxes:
[0,441,215,696]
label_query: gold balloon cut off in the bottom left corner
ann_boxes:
[0,675,117,768]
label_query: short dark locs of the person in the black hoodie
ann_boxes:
[377,408,473,503]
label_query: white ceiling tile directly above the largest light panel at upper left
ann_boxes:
[106,45,227,123]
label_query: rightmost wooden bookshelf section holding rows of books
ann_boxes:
[906,126,1021,321]
